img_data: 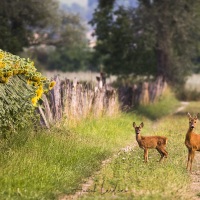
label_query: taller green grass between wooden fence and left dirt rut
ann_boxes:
[0,115,141,200]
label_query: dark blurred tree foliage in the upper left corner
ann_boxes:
[0,0,59,54]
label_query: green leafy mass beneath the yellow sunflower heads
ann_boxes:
[0,75,37,139]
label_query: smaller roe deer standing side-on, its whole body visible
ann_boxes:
[133,122,168,162]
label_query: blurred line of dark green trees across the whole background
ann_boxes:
[0,0,200,84]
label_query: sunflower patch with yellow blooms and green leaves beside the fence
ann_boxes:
[0,50,55,136]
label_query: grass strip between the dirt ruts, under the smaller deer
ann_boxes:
[82,116,194,200]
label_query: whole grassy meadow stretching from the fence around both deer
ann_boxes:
[0,72,200,200]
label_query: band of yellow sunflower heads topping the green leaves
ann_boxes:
[0,49,55,106]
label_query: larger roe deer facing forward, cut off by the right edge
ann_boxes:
[185,113,200,172]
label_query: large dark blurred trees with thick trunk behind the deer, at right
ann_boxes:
[91,0,200,84]
